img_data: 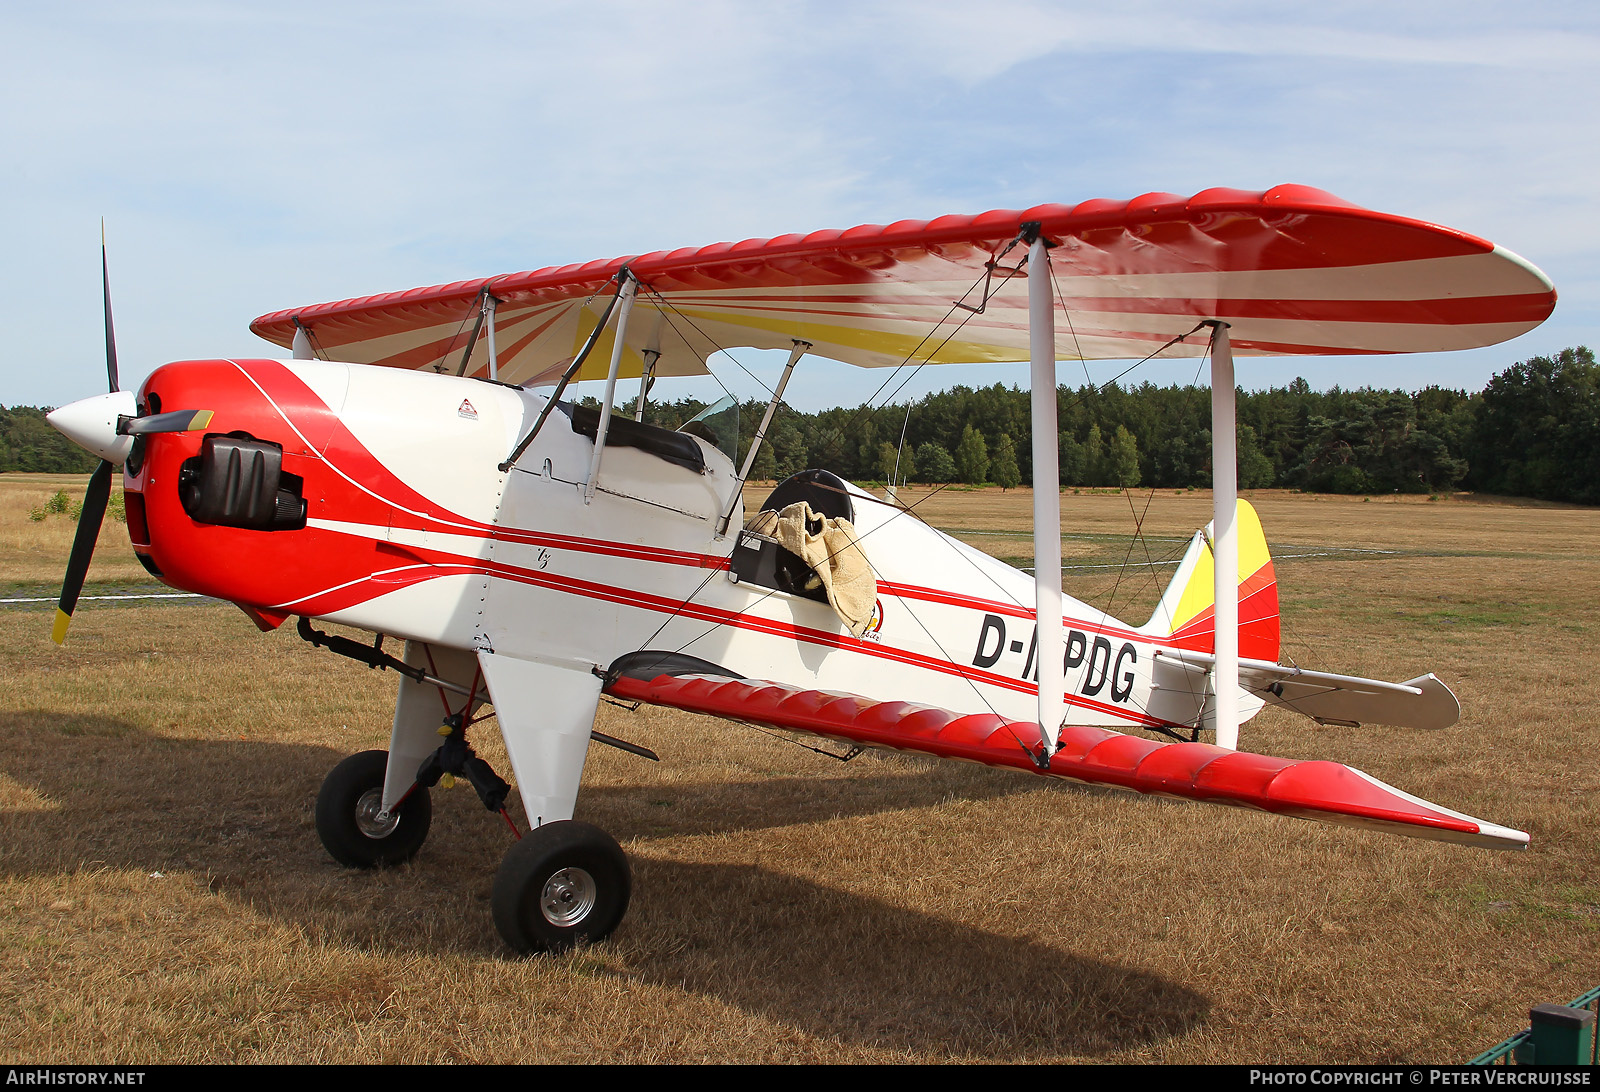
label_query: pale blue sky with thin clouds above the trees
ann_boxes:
[0,0,1600,410]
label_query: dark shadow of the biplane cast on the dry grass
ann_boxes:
[0,711,1210,1058]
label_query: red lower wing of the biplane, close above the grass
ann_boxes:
[606,653,1528,849]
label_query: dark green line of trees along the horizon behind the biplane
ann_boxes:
[9,346,1600,504]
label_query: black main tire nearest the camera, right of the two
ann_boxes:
[490,820,634,954]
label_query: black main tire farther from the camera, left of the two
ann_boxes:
[317,751,434,868]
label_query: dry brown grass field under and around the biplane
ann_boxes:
[0,476,1600,1063]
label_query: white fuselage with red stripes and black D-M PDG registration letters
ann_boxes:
[288,362,1205,736]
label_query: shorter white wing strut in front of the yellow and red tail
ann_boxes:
[1211,322,1238,751]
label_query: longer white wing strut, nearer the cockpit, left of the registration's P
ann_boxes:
[1027,235,1066,753]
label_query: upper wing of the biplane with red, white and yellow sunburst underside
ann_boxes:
[251,186,1555,383]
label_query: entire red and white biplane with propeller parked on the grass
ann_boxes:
[51,186,1555,951]
